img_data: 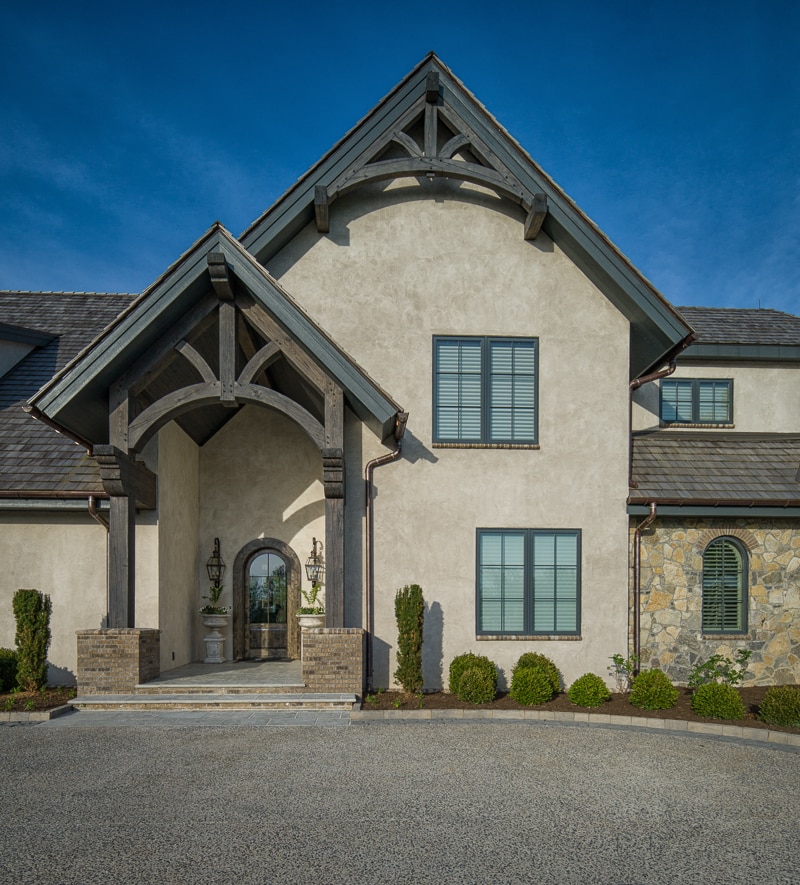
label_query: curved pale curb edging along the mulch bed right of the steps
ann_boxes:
[350,710,800,747]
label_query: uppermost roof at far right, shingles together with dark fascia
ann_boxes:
[676,307,800,360]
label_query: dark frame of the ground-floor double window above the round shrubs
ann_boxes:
[475,528,583,640]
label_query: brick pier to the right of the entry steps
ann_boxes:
[302,627,365,697]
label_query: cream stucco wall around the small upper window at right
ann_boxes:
[633,362,800,433]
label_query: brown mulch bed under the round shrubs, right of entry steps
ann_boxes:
[361,686,800,734]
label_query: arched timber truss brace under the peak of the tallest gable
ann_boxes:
[314,72,547,240]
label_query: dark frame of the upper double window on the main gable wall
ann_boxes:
[431,335,539,448]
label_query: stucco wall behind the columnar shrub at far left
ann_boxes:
[0,511,107,685]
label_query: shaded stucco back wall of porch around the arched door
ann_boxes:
[195,406,325,659]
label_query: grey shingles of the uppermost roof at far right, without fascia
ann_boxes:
[675,307,800,345]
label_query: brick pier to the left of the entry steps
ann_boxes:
[77,627,161,695]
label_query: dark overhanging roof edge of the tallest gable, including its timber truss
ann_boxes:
[240,53,691,378]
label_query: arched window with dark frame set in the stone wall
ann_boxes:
[703,537,747,633]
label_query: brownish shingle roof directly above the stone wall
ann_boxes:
[629,431,800,507]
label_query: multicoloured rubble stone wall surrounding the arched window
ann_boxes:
[631,517,800,685]
